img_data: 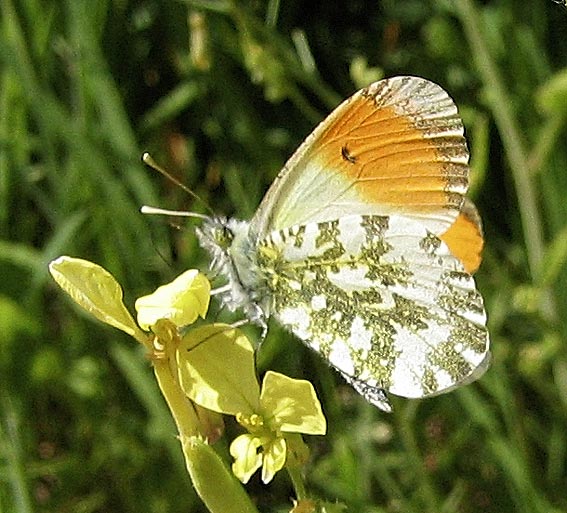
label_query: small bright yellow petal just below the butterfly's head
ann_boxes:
[135,269,211,329]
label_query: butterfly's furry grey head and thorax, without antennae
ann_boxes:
[197,217,269,327]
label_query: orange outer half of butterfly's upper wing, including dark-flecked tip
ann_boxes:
[308,76,468,217]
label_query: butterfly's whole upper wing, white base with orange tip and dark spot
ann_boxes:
[252,77,468,242]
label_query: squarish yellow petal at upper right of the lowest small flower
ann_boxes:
[260,371,327,435]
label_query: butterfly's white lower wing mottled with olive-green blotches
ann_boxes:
[258,215,488,410]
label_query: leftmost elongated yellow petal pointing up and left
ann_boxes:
[49,256,146,341]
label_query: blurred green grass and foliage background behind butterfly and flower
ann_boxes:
[0,0,567,513]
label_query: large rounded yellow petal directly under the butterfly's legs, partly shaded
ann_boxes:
[177,324,260,415]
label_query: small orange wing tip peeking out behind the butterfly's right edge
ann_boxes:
[440,199,484,274]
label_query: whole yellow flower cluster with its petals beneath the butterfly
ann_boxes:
[49,257,326,483]
